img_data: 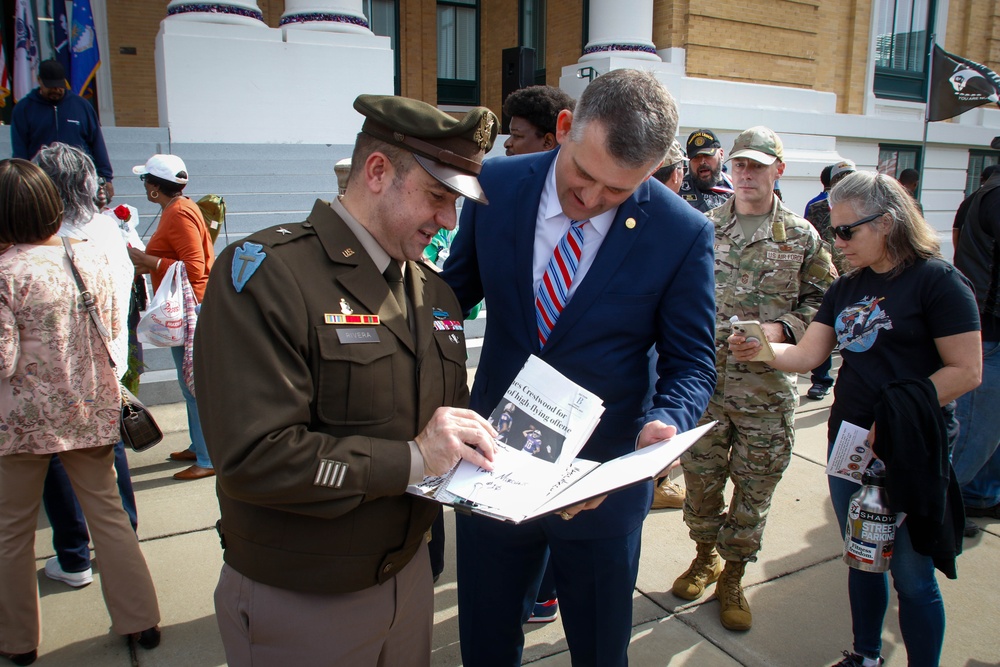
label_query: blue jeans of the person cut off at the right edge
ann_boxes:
[951,341,1000,508]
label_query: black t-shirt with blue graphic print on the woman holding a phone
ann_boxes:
[816,259,979,441]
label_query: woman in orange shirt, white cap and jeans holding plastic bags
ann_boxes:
[129,155,215,480]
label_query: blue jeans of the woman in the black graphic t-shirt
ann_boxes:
[827,470,945,667]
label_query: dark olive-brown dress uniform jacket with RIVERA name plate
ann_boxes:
[195,201,469,594]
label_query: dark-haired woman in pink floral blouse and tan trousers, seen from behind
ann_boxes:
[0,159,160,665]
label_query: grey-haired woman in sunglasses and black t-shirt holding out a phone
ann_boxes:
[729,172,982,667]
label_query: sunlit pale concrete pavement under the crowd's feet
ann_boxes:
[21,380,1000,667]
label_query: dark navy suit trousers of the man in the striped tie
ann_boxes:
[455,514,642,667]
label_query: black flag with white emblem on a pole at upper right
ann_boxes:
[927,44,1000,121]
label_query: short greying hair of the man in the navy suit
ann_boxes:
[570,69,677,169]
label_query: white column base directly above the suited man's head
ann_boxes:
[579,0,660,63]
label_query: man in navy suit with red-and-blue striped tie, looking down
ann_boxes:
[443,70,715,667]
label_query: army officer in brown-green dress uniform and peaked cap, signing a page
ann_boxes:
[195,95,497,667]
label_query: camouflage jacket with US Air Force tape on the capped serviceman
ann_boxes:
[706,197,837,411]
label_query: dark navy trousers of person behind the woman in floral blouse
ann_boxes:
[42,442,139,572]
